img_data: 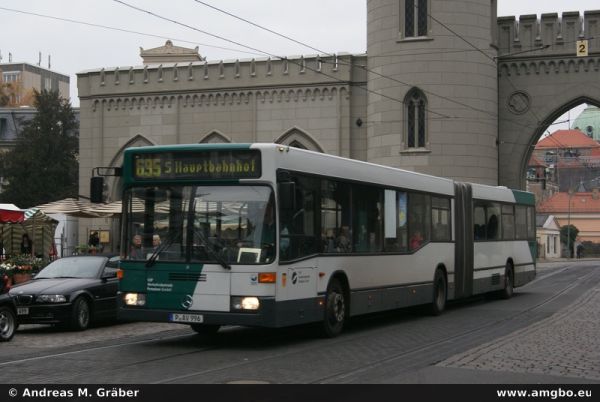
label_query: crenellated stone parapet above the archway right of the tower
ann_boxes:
[497,10,600,57]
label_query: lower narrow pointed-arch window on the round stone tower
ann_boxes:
[404,88,427,148]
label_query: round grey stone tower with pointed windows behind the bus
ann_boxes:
[367,0,498,185]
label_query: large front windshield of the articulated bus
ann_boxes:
[124,185,276,268]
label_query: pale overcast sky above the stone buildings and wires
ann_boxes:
[0,0,600,128]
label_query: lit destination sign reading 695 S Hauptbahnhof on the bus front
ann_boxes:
[133,150,261,180]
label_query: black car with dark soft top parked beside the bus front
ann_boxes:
[9,255,118,331]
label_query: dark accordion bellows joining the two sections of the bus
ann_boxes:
[454,183,474,298]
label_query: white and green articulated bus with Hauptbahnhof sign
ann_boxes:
[119,144,536,336]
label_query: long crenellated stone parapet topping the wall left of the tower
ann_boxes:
[78,54,366,99]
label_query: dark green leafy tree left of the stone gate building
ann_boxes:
[0,90,79,208]
